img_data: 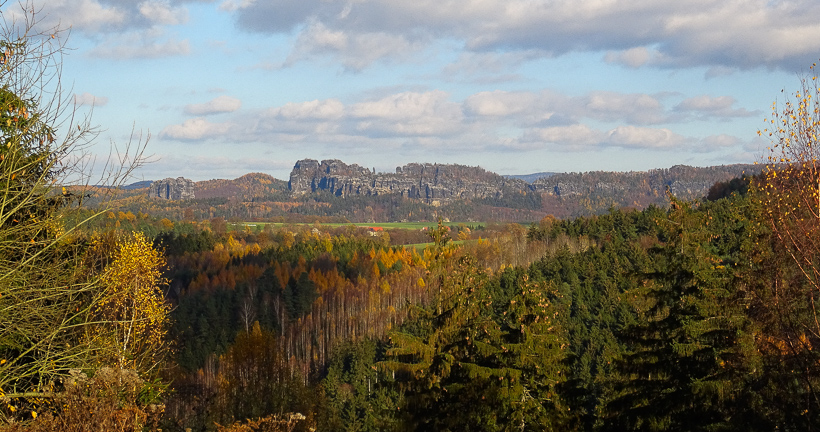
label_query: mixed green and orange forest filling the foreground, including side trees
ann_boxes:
[0,3,820,432]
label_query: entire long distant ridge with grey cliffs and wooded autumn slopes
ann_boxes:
[99,159,761,222]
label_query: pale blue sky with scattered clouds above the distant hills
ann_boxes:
[6,0,820,181]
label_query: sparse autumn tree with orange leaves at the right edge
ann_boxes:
[751,64,820,428]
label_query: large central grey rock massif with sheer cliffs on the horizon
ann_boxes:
[288,159,529,204]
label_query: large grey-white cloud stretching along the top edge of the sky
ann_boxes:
[232,0,820,69]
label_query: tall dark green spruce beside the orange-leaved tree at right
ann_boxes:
[605,199,755,430]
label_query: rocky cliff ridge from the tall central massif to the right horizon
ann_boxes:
[289,159,760,215]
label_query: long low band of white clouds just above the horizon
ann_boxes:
[160,90,755,156]
